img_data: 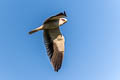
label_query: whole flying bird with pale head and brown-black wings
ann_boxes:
[29,11,67,72]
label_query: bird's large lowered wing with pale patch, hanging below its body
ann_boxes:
[44,28,64,71]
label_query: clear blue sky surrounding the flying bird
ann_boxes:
[0,0,120,80]
